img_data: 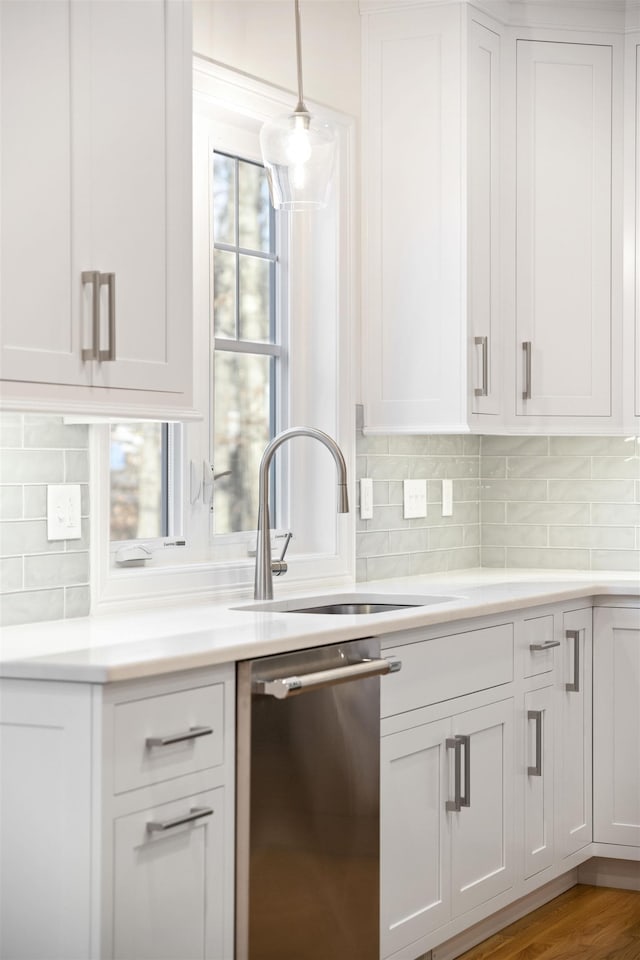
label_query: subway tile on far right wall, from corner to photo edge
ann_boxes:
[480,437,640,576]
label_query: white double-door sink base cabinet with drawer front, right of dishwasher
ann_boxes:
[381,623,514,957]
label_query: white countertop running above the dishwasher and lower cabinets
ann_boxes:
[0,569,640,683]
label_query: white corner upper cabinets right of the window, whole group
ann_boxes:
[361,0,640,434]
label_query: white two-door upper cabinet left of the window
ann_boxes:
[0,0,192,416]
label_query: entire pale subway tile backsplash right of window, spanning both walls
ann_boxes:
[357,411,640,580]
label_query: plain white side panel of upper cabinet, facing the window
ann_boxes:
[363,4,467,433]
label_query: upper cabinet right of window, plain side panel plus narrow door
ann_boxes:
[363,5,500,433]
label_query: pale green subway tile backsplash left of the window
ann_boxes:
[0,413,90,626]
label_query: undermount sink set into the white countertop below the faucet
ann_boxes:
[234,594,458,616]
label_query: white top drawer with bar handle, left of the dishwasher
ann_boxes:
[113,683,224,793]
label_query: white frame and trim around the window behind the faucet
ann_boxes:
[91,57,359,613]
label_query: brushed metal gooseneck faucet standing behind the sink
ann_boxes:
[253,427,349,600]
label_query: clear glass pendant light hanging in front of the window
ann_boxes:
[260,0,336,210]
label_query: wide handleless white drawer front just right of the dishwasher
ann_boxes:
[381,623,513,717]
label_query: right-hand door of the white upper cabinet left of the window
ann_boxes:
[72,0,191,391]
